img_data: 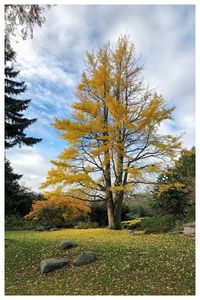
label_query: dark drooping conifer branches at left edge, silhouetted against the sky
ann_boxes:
[5,51,41,148]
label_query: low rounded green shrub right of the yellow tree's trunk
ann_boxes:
[141,215,175,233]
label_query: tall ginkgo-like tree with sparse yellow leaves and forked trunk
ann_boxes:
[42,36,180,229]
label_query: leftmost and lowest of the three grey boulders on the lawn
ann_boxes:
[40,258,69,274]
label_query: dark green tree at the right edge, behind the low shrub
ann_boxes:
[151,147,195,218]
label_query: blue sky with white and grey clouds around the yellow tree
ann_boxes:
[7,5,195,191]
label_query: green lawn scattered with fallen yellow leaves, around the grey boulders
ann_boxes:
[5,229,195,295]
